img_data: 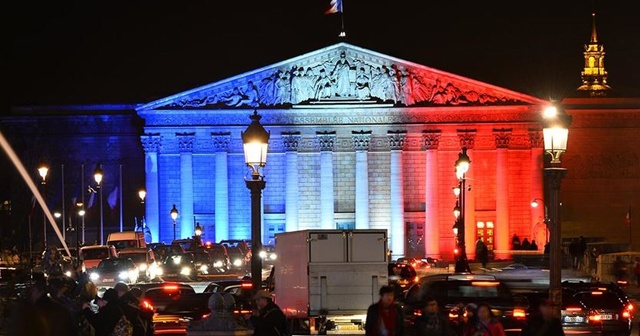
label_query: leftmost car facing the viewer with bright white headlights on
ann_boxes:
[89,258,139,287]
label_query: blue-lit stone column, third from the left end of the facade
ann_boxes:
[211,132,231,242]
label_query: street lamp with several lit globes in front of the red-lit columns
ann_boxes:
[453,147,471,272]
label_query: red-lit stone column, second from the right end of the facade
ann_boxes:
[493,128,511,259]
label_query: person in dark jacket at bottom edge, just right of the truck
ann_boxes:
[364,285,404,336]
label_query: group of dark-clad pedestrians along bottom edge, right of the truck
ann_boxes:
[365,286,564,336]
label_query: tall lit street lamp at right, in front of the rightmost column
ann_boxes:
[542,106,572,317]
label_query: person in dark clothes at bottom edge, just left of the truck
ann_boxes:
[249,289,288,336]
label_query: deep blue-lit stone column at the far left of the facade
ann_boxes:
[140,133,161,243]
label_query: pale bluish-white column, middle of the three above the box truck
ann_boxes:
[316,132,336,229]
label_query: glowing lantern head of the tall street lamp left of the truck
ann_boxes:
[241,111,271,175]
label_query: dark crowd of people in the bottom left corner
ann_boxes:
[8,274,154,336]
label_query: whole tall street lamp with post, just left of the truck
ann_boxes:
[242,111,270,291]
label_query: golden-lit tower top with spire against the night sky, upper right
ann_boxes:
[578,13,611,97]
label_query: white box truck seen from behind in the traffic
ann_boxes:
[274,229,389,334]
